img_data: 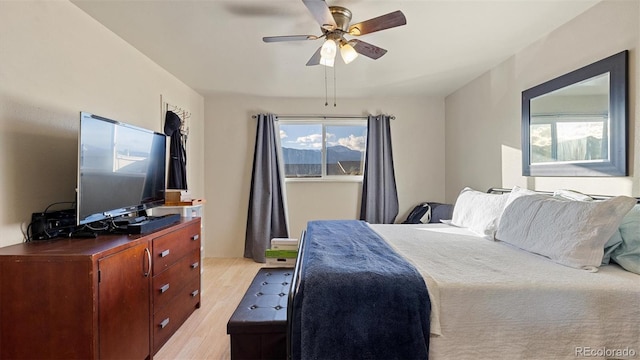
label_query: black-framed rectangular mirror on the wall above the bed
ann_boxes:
[522,50,629,176]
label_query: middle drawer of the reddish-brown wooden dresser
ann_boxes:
[152,249,200,313]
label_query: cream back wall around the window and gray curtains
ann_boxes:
[205,95,444,257]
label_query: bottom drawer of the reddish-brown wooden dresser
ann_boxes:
[153,277,200,353]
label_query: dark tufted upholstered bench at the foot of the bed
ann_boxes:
[227,268,293,360]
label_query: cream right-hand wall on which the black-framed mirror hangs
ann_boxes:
[445,0,640,202]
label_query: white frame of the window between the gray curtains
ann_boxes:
[276,118,369,183]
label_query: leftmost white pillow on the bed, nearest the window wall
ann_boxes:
[450,187,507,240]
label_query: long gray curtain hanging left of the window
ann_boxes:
[244,114,289,263]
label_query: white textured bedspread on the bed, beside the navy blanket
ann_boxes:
[370,224,640,360]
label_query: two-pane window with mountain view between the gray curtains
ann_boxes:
[278,120,367,180]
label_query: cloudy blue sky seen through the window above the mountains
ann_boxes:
[280,124,367,151]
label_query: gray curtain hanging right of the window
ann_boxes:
[360,115,398,224]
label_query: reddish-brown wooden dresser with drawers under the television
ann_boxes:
[0,218,200,359]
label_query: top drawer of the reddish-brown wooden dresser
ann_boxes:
[153,223,200,275]
